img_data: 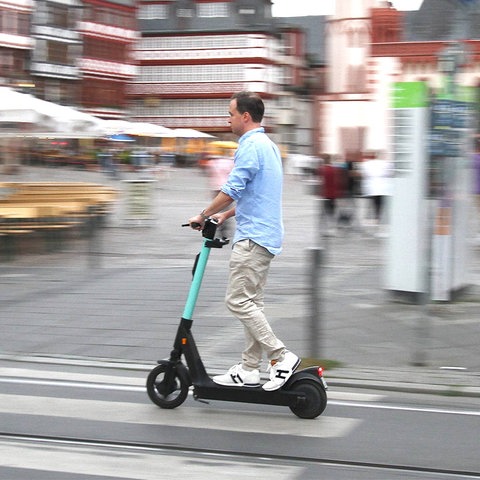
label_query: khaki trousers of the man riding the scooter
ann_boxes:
[225,240,285,370]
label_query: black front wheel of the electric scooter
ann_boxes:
[147,364,190,409]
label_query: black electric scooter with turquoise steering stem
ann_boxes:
[147,218,328,419]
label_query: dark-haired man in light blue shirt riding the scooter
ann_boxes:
[189,92,300,391]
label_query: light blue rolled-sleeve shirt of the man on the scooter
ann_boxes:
[221,127,283,255]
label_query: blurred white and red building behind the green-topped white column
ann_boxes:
[315,0,480,157]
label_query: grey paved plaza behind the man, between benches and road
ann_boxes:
[0,163,480,394]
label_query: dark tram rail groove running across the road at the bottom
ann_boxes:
[0,432,480,479]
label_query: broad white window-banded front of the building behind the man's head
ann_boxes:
[129,33,280,132]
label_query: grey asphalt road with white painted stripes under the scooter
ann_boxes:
[0,363,480,480]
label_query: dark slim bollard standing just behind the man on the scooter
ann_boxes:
[308,247,323,358]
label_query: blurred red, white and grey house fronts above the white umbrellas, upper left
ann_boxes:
[0,0,138,118]
